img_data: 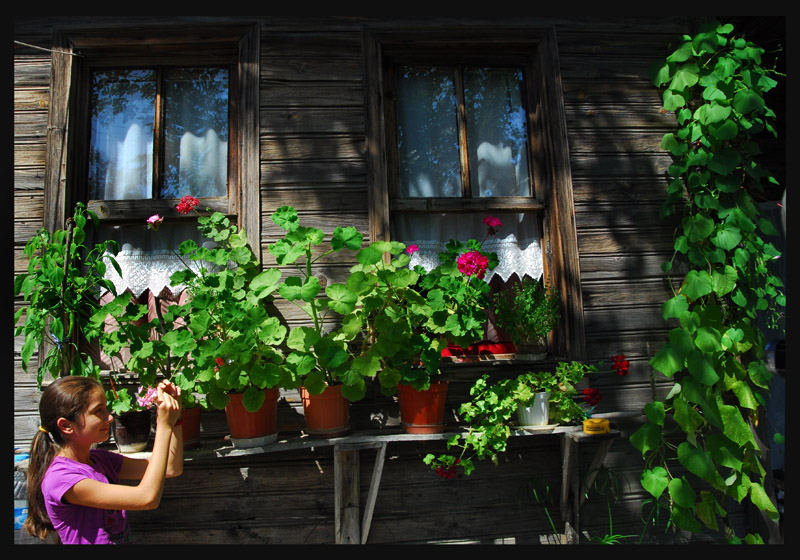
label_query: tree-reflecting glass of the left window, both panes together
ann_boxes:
[89,68,229,200]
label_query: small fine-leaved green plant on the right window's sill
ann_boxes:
[492,276,560,360]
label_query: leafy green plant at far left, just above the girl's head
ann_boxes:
[14,204,120,388]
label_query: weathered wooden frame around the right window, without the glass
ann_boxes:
[363,27,585,360]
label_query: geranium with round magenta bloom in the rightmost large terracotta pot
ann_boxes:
[346,221,497,433]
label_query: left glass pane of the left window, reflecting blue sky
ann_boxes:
[89,70,156,200]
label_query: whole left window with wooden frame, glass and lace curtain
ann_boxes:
[45,26,260,296]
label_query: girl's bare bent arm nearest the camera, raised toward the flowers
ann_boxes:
[64,383,183,510]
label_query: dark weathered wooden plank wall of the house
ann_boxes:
[14,16,780,544]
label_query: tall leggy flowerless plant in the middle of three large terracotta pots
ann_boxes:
[269,206,369,437]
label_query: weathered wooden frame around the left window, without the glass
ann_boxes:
[44,25,261,262]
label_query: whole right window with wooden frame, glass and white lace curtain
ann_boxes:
[366,29,583,357]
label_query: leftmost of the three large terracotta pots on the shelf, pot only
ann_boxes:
[225,387,280,447]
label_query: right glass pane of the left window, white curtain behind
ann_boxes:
[161,68,229,198]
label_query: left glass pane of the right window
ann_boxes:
[397,67,461,198]
